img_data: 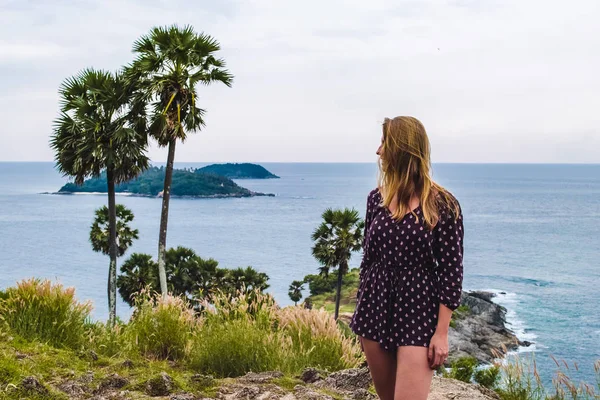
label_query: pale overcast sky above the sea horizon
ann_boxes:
[0,0,600,163]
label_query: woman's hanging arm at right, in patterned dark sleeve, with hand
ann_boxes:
[428,207,464,369]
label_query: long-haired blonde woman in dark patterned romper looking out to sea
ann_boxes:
[350,117,463,400]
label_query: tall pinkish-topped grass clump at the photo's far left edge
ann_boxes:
[0,279,92,349]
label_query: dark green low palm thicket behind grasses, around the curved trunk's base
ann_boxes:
[117,247,269,306]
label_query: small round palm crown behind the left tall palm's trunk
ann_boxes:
[90,204,138,257]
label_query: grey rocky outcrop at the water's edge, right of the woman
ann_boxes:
[448,291,529,363]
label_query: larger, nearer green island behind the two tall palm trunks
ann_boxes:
[58,167,274,198]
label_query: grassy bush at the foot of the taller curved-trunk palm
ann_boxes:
[124,294,200,360]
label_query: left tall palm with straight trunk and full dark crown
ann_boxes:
[50,69,148,325]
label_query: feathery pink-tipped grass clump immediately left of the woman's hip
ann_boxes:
[278,307,362,372]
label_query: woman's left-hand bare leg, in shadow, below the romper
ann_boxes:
[360,337,396,400]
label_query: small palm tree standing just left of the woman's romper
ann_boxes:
[312,208,365,320]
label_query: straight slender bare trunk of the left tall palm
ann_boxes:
[106,168,117,326]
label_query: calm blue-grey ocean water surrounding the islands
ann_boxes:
[0,163,600,381]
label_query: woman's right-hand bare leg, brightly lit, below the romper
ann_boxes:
[394,346,433,400]
